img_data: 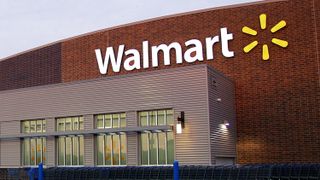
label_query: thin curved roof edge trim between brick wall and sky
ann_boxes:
[0,0,289,61]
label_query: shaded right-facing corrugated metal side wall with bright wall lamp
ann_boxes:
[208,68,236,163]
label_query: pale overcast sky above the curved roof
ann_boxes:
[0,0,257,59]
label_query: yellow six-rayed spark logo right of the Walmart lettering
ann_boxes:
[242,14,288,60]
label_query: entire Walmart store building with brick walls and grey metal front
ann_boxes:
[0,0,320,167]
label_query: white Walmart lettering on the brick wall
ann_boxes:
[95,28,234,74]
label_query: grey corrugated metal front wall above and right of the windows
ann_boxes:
[0,65,210,165]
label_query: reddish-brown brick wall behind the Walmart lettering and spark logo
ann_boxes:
[0,0,320,163]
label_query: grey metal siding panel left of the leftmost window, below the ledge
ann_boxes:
[0,139,21,167]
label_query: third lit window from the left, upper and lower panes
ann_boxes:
[95,113,127,165]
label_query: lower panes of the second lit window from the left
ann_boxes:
[58,135,84,166]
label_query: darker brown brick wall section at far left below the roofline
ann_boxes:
[0,44,61,91]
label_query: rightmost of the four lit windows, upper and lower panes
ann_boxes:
[139,110,174,165]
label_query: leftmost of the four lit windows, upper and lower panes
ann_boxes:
[21,120,46,166]
